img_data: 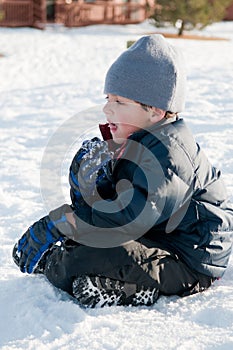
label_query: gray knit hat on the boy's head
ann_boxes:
[104,34,186,112]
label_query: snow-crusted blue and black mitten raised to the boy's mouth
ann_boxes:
[69,137,112,208]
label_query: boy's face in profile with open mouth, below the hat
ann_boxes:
[103,94,165,144]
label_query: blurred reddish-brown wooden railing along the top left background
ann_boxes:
[0,0,147,28]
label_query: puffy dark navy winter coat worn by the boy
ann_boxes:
[67,119,233,277]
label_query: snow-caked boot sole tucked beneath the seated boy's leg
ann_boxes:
[73,276,158,308]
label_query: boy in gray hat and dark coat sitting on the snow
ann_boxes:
[13,35,233,307]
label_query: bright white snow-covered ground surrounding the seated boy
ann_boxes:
[0,22,233,350]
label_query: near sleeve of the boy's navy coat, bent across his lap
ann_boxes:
[66,139,197,248]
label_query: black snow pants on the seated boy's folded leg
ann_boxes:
[44,238,213,296]
